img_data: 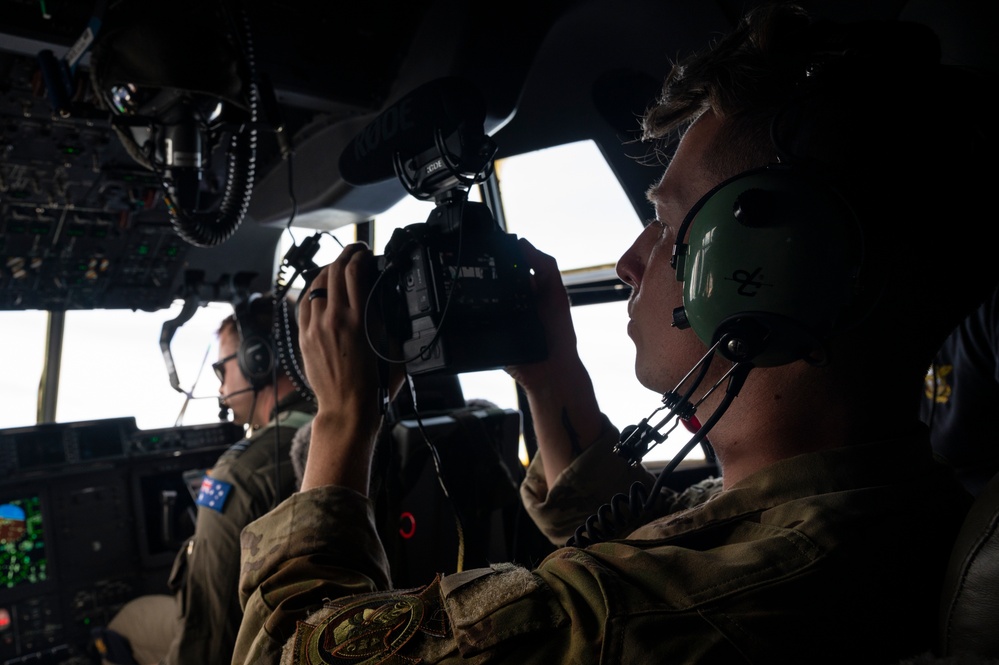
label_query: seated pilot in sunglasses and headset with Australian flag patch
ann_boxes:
[98,294,315,665]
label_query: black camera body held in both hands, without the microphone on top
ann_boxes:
[377,197,547,375]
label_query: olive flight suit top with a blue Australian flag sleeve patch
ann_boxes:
[160,393,315,665]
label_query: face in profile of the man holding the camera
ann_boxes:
[617,113,720,393]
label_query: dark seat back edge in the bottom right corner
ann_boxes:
[940,474,999,658]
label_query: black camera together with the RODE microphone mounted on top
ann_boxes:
[354,80,547,375]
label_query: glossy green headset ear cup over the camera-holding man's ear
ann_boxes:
[671,164,863,367]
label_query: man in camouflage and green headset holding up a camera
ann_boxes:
[233,5,995,665]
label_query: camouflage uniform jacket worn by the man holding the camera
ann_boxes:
[233,423,970,665]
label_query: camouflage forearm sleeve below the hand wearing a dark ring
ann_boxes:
[232,486,391,665]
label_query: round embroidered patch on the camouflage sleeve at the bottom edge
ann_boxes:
[295,582,447,665]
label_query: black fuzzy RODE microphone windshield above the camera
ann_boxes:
[339,77,486,185]
